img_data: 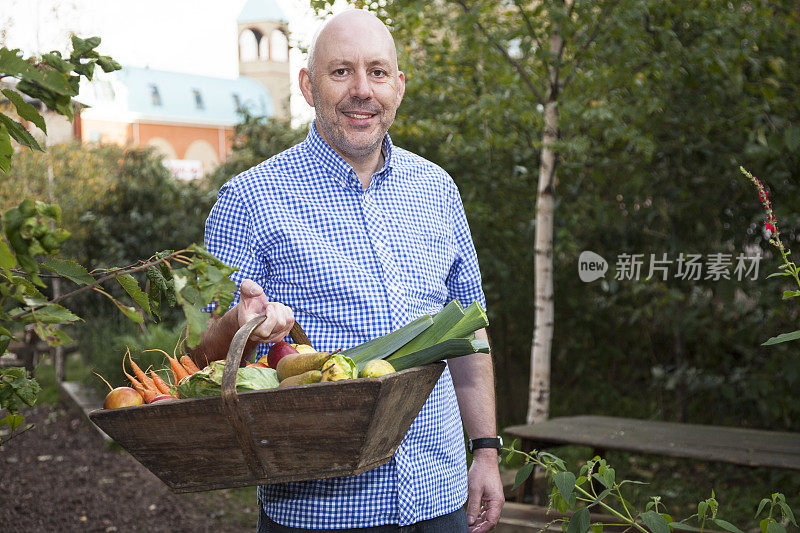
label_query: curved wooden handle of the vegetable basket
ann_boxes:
[221,315,311,478]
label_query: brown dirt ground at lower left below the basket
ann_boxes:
[0,405,257,533]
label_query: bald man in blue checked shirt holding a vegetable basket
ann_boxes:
[193,10,504,533]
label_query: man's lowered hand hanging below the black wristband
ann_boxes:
[467,449,506,533]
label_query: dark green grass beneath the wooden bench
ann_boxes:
[508,446,800,531]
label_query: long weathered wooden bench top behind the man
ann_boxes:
[505,416,800,501]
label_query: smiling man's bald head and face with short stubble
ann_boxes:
[301,16,405,161]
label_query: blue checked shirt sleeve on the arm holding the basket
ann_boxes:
[205,183,267,307]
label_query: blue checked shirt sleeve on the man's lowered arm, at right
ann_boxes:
[445,183,486,309]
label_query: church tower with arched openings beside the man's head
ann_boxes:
[236,0,291,120]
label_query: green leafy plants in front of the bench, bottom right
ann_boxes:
[504,441,797,533]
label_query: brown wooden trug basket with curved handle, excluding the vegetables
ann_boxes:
[89,317,444,492]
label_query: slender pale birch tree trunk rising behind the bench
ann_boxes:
[527,0,572,424]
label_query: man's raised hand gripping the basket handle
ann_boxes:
[241,279,294,342]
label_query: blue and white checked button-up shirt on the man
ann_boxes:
[206,125,485,529]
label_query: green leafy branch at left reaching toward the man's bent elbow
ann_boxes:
[0,200,236,443]
